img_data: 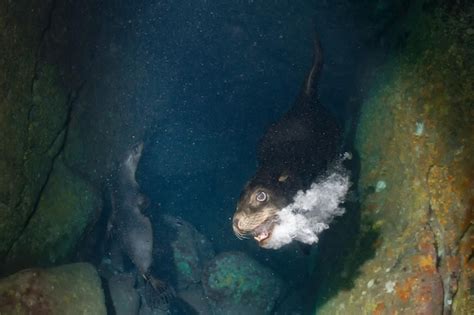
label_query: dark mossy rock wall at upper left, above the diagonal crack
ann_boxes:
[0,1,100,264]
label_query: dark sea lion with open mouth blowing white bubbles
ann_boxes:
[232,40,341,247]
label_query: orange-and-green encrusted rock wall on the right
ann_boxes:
[316,4,474,314]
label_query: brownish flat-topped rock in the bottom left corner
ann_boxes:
[0,263,106,315]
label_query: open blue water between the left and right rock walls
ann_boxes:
[88,0,370,314]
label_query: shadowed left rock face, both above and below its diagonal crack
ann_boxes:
[0,1,104,273]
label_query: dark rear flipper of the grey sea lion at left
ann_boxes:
[142,272,176,310]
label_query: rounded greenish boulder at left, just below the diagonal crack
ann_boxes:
[7,158,101,270]
